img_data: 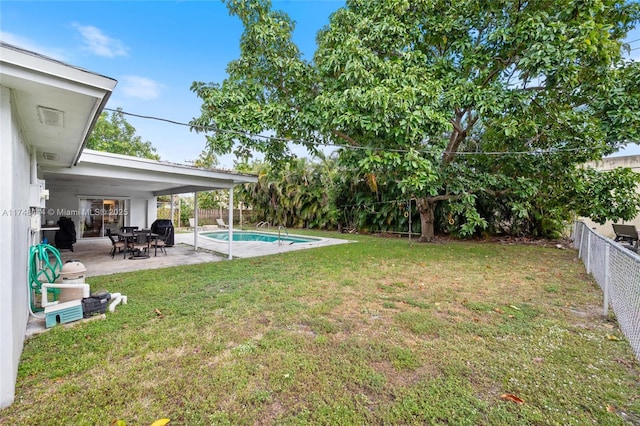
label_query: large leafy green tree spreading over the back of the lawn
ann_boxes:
[192,0,640,241]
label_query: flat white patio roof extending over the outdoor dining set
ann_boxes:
[40,149,258,197]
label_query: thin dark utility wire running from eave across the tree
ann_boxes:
[104,107,604,156]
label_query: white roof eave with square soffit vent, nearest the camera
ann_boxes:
[0,42,117,167]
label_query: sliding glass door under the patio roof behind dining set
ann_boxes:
[80,198,127,238]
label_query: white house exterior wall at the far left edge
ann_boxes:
[0,87,38,408]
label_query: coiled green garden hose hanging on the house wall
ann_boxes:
[29,244,62,314]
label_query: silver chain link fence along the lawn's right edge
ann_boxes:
[573,222,640,360]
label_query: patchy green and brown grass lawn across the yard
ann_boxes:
[0,234,640,425]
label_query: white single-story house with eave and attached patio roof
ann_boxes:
[0,42,257,409]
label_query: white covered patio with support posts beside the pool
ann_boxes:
[40,150,257,259]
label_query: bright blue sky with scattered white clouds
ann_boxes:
[0,0,640,169]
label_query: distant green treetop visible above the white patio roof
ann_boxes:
[87,108,160,160]
